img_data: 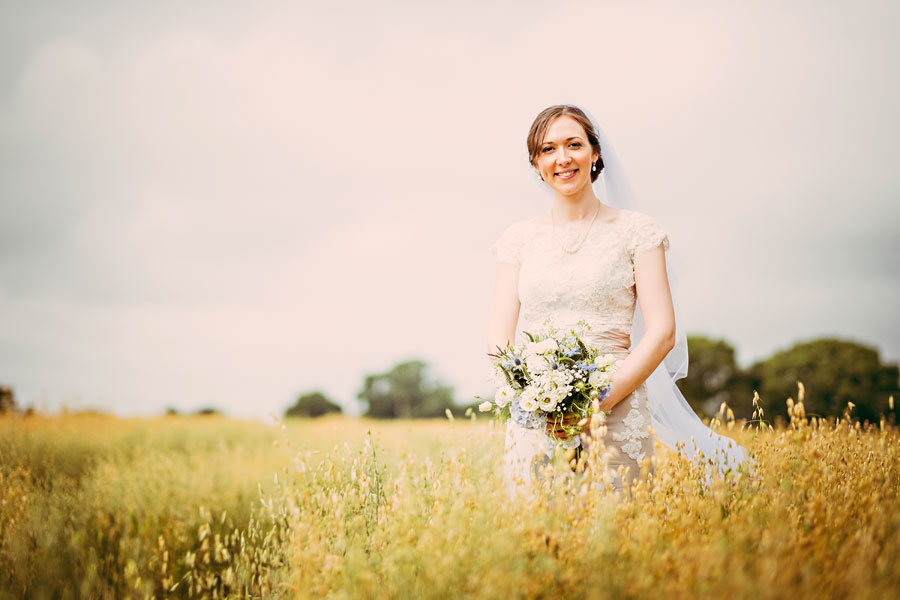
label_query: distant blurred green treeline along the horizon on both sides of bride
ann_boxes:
[285,335,900,422]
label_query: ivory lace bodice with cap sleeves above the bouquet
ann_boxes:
[491,210,669,342]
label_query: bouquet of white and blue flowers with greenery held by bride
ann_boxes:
[479,321,617,445]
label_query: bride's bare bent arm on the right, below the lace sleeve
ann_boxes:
[600,244,675,411]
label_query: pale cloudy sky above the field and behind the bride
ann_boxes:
[0,0,900,418]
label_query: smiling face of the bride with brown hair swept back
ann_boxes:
[534,115,600,196]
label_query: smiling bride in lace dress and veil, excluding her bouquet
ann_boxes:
[488,105,744,491]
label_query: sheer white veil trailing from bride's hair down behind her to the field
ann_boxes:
[582,116,747,473]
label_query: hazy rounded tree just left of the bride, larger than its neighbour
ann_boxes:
[357,360,455,419]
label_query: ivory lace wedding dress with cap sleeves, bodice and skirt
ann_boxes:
[491,210,669,490]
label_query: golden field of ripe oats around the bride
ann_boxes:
[0,408,900,599]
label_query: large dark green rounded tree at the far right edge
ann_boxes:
[750,339,900,421]
